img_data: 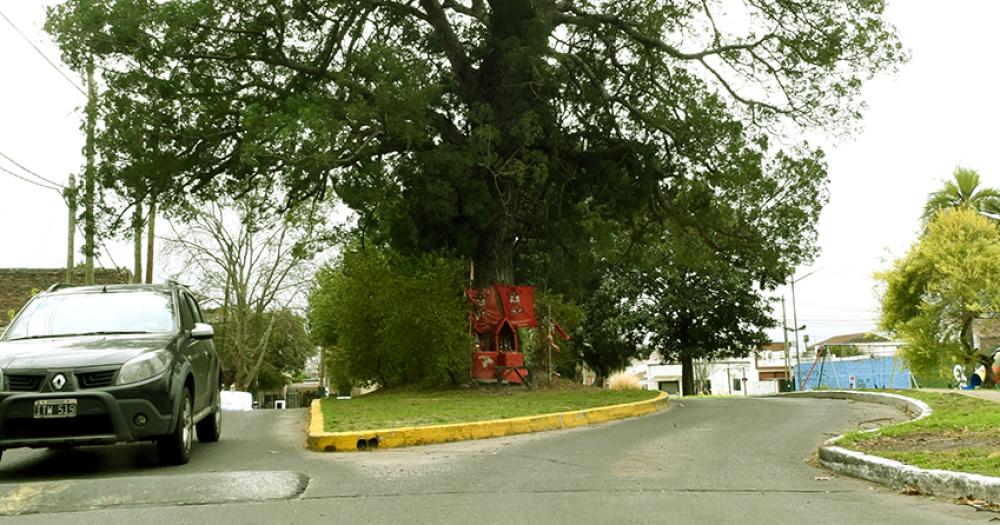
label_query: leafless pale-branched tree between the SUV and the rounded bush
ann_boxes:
[165,194,322,390]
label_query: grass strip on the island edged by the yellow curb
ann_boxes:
[321,388,659,432]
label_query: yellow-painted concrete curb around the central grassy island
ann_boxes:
[306,392,667,452]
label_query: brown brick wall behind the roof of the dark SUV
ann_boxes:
[0,268,132,327]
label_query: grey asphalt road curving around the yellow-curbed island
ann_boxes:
[0,399,988,525]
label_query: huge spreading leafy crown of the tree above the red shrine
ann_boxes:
[47,0,903,284]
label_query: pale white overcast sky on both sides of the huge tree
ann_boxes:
[0,0,1000,343]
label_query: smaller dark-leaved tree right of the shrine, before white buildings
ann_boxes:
[584,227,780,394]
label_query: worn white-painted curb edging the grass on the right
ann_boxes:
[781,391,1000,503]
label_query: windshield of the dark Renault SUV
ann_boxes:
[4,290,174,341]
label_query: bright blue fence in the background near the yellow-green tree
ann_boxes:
[796,356,910,390]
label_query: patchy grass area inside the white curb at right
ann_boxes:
[838,390,1000,476]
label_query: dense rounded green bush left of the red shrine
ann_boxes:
[309,248,469,387]
